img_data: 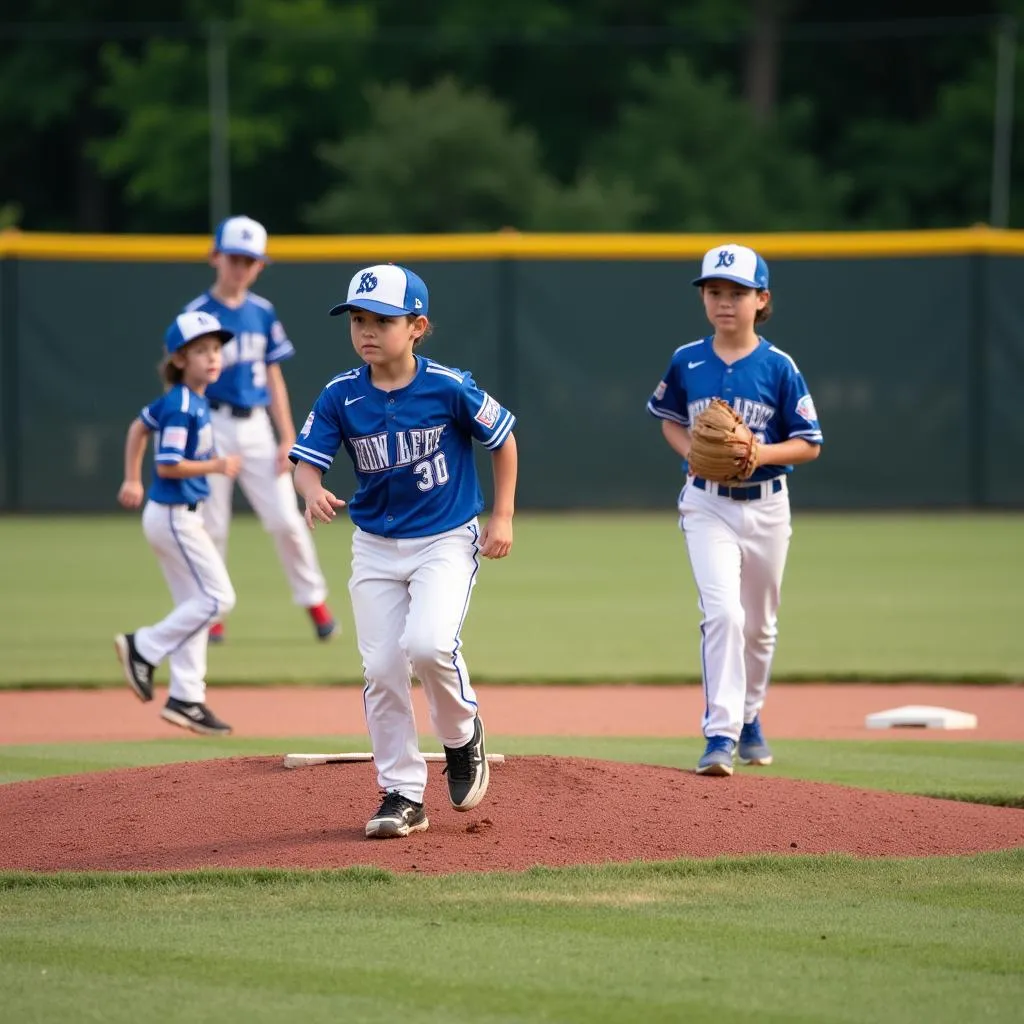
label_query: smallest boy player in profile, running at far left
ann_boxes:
[114,312,242,735]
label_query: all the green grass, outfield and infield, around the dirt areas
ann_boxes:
[0,512,1024,1024]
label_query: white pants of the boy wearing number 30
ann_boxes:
[348,519,480,803]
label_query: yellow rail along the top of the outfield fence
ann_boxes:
[6,225,1024,263]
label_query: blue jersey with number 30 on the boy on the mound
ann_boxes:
[291,356,516,538]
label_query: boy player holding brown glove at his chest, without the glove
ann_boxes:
[647,244,822,775]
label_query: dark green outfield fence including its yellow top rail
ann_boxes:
[0,227,1024,512]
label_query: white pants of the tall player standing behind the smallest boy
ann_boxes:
[205,407,327,608]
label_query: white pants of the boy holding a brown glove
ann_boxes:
[679,477,793,740]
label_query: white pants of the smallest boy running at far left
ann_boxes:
[135,502,234,703]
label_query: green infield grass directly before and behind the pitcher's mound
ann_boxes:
[0,737,1024,1024]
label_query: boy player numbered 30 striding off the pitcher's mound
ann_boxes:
[292,264,517,838]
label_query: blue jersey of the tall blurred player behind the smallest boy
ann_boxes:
[184,292,295,409]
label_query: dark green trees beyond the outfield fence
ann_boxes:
[0,0,1024,233]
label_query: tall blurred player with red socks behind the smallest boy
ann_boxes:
[185,217,338,643]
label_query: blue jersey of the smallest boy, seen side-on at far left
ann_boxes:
[138,384,214,505]
